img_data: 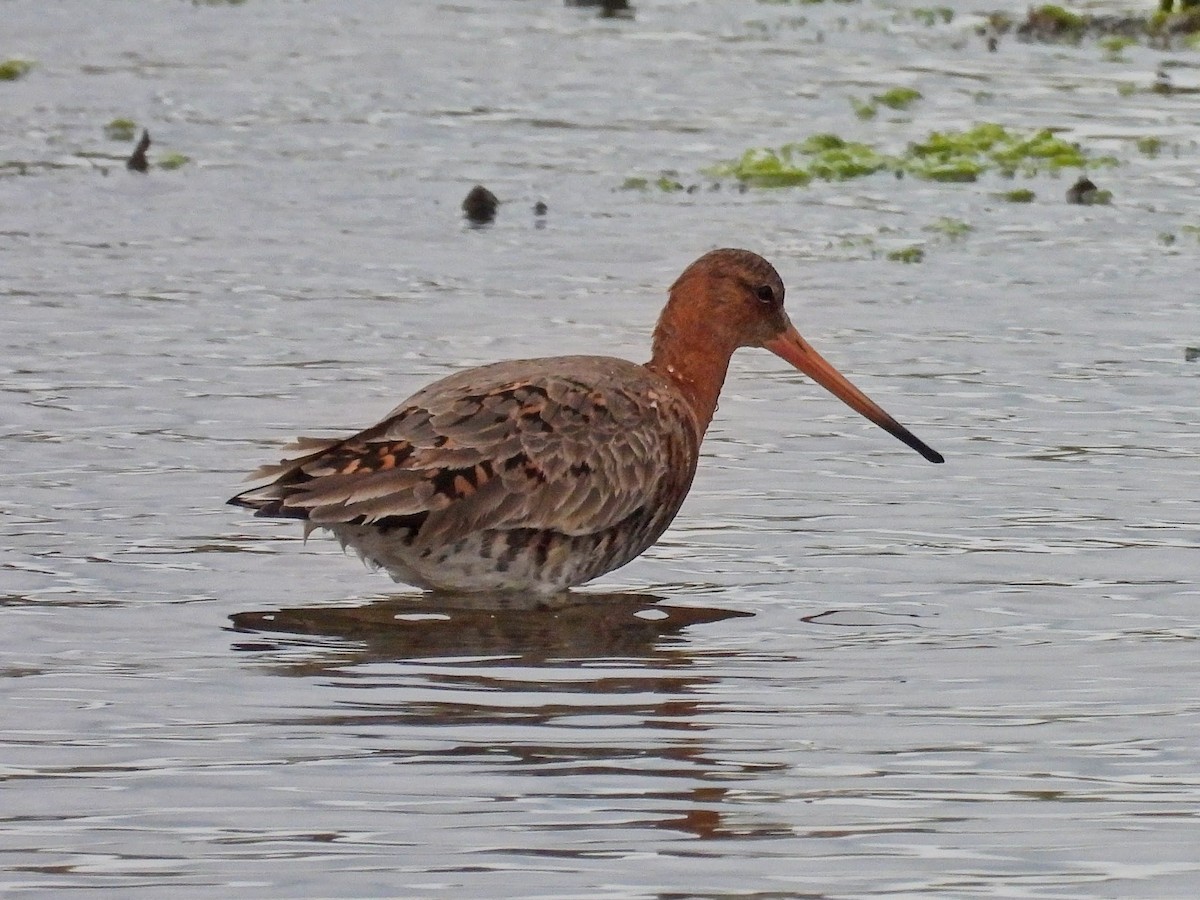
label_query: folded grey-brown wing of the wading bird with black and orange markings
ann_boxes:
[230,356,698,542]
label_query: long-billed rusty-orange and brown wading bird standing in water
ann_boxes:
[228,248,943,596]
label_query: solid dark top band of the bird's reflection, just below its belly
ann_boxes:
[230,593,752,666]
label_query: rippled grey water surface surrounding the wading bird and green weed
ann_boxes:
[0,0,1200,898]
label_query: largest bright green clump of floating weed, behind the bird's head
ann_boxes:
[710,122,1116,187]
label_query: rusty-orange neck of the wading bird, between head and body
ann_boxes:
[646,296,737,438]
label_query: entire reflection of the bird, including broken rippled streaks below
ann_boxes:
[230,593,806,844]
